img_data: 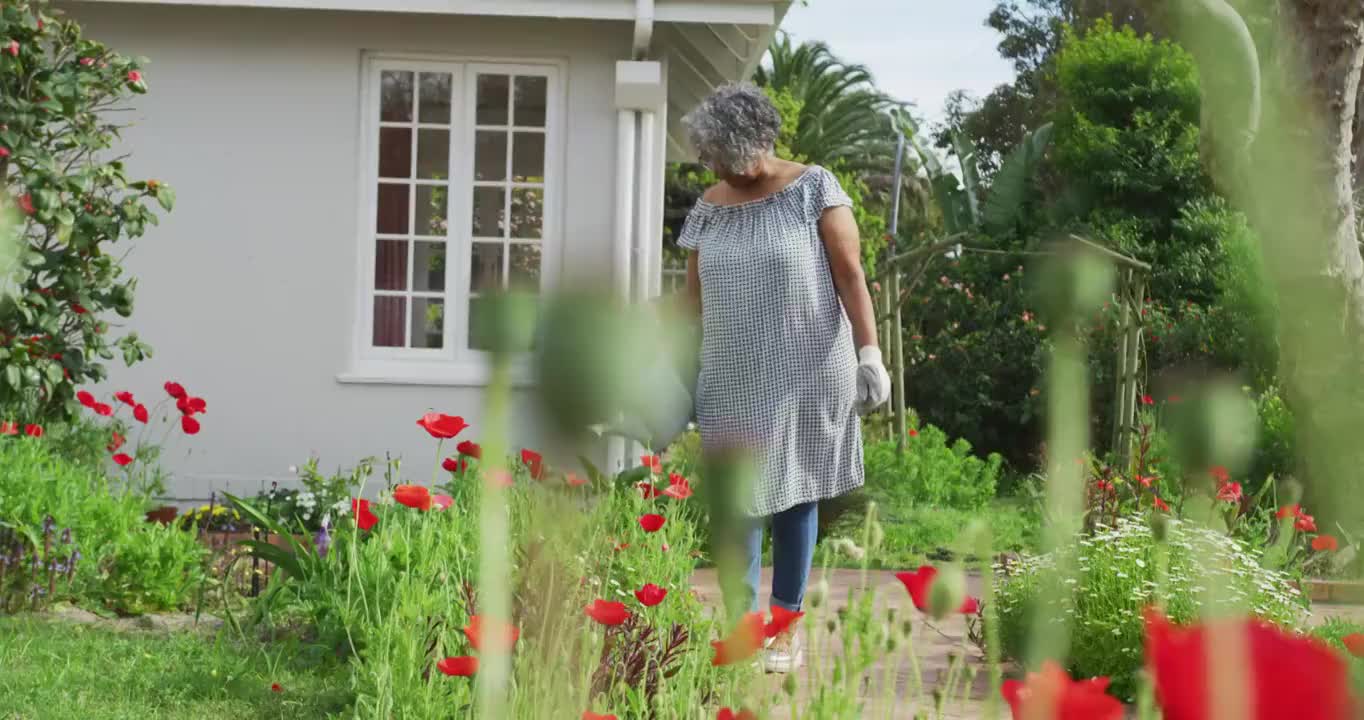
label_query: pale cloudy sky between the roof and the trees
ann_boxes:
[782,0,1013,129]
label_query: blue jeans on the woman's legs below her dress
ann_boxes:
[722,502,820,616]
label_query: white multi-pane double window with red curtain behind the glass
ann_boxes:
[357,57,558,379]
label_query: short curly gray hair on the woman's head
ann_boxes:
[682,83,782,175]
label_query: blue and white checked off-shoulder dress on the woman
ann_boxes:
[678,166,863,515]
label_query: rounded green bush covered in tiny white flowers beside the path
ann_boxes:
[996,517,1307,700]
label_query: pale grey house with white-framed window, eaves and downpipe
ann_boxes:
[63,0,790,499]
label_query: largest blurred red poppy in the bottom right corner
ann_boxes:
[1146,611,1353,720]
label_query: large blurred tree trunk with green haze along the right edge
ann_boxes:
[1163,0,1364,524]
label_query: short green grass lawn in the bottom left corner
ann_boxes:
[0,615,349,720]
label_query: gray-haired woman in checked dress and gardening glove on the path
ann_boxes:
[678,85,891,672]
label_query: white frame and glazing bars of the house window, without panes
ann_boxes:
[337,53,567,386]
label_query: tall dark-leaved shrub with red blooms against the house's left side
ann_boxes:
[0,0,175,421]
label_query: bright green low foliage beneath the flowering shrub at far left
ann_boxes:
[0,438,206,614]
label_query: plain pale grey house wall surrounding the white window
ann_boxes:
[65,3,630,499]
